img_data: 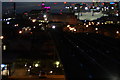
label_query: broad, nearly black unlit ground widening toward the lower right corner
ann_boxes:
[51,30,120,80]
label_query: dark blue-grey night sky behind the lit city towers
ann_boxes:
[2,2,91,13]
